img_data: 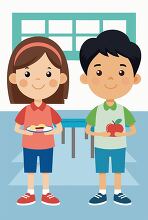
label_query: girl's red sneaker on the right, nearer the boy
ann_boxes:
[42,193,60,206]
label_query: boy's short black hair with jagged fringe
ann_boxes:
[80,30,141,76]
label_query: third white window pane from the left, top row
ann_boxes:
[76,20,100,34]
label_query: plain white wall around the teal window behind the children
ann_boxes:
[0,0,148,111]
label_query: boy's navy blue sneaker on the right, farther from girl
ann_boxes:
[114,193,132,206]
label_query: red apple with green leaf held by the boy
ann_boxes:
[106,119,124,137]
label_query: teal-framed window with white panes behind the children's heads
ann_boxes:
[12,13,136,60]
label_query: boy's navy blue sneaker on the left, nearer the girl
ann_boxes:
[88,193,107,206]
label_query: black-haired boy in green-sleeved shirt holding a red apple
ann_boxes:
[80,30,141,205]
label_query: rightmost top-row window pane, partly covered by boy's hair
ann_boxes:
[103,20,126,33]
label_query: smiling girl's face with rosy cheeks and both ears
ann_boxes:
[9,53,67,100]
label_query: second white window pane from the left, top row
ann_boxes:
[49,20,72,34]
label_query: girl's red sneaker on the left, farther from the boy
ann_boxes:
[16,193,36,206]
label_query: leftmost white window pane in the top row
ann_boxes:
[22,20,45,34]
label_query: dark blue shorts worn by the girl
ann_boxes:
[23,148,53,173]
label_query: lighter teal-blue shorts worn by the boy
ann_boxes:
[95,148,126,173]
